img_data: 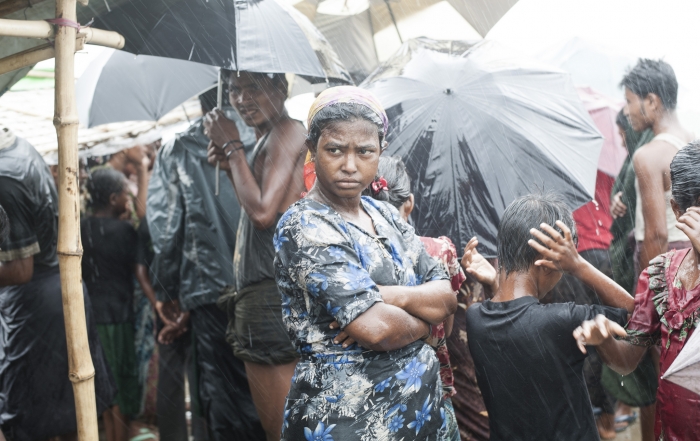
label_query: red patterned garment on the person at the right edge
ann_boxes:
[626,248,700,441]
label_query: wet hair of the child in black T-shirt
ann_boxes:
[498,193,578,275]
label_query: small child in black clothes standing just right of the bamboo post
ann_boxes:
[80,168,140,441]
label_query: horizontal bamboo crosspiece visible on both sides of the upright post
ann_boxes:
[0,17,124,49]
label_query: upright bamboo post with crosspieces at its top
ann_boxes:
[0,0,124,441]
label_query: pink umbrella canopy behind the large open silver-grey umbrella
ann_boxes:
[577,87,629,177]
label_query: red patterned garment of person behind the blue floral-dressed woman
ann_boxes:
[420,236,467,398]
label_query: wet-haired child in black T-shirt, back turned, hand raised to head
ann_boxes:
[462,194,634,441]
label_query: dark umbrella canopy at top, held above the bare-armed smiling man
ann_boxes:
[95,0,352,83]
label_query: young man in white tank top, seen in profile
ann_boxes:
[620,59,694,270]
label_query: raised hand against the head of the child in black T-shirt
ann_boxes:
[527,221,582,273]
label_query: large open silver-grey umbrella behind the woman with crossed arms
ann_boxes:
[363,39,602,256]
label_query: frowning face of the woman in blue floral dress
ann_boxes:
[312,118,381,199]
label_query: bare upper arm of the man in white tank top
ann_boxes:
[634,146,668,268]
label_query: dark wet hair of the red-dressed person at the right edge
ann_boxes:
[671,140,700,212]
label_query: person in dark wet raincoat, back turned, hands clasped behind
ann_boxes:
[147,90,264,441]
